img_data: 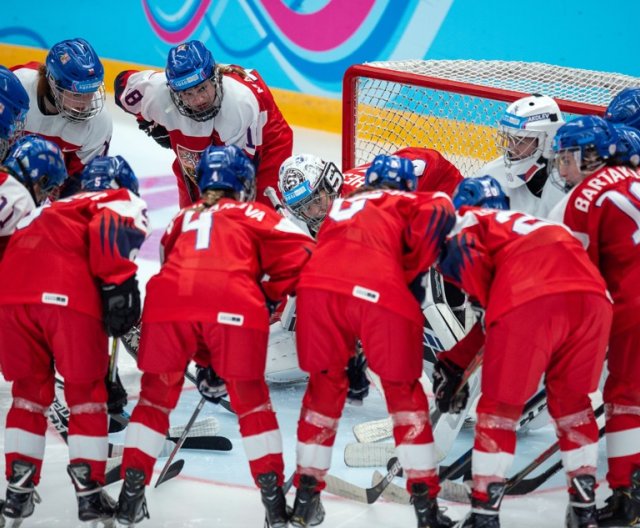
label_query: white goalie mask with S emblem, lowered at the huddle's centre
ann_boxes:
[278,154,344,230]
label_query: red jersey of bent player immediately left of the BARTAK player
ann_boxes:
[438,207,606,325]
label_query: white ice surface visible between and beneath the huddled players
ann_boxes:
[0,105,609,528]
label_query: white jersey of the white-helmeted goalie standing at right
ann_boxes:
[472,157,565,218]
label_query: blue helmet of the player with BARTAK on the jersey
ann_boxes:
[553,115,617,172]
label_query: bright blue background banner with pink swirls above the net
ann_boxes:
[0,0,640,98]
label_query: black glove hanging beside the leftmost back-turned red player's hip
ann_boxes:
[100,275,140,337]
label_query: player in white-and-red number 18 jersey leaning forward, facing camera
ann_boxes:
[115,40,293,207]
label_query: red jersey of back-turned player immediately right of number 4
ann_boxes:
[299,190,455,324]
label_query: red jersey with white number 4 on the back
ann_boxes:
[142,198,314,330]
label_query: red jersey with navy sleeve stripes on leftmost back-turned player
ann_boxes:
[0,189,149,318]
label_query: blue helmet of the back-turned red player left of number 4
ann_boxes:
[80,156,140,196]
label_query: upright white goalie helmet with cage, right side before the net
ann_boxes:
[498,94,564,189]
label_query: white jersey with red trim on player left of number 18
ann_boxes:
[12,62,113,176]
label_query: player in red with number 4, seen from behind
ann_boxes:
[117,145,314,528]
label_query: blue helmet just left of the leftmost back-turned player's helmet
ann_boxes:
[4,134,68,204]
